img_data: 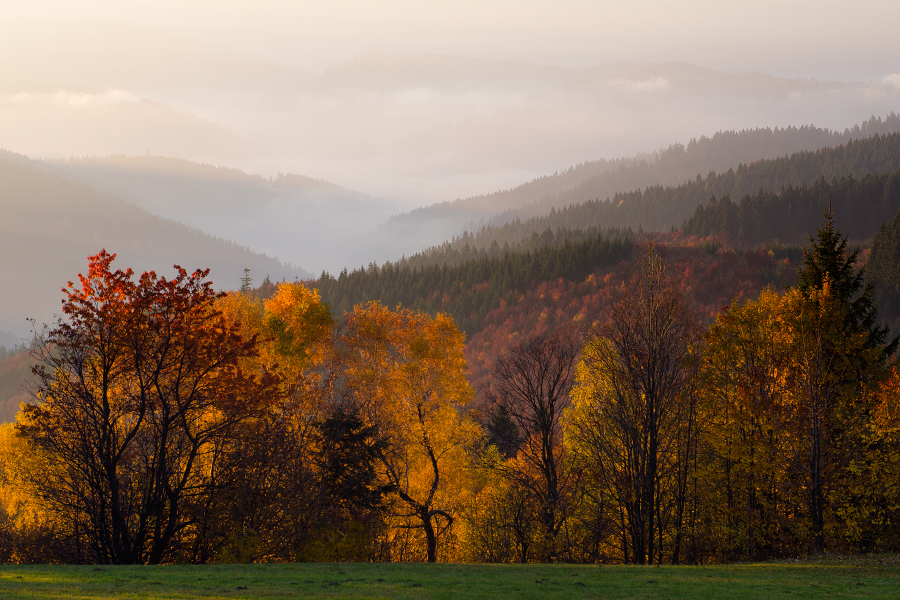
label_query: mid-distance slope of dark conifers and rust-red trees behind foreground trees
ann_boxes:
[310,233,802,388]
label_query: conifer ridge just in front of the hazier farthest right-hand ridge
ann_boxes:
[406,133,900,263]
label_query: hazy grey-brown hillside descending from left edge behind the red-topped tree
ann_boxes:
[0,157,308,338]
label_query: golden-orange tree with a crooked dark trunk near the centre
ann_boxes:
[342,302,477,562]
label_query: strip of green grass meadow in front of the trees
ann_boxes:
[0,555,900,600]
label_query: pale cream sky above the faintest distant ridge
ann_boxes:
[4,0,900,80]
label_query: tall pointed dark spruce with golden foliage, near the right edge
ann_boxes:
[784,209,898,553]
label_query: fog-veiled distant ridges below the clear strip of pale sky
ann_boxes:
[0,11,900,209]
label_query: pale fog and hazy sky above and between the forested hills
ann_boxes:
[0,0,900,272]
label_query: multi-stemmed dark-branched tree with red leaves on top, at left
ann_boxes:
[18,250,277,564]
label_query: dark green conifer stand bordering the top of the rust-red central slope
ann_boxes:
[314,231,634,333]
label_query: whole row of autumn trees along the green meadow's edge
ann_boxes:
[0,218,900,564]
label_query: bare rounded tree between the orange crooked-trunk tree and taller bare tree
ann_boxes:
[486,329,578,562]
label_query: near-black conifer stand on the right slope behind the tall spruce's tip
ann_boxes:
[681,170,900,247]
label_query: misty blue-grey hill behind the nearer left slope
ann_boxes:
[49,156,393,272]
